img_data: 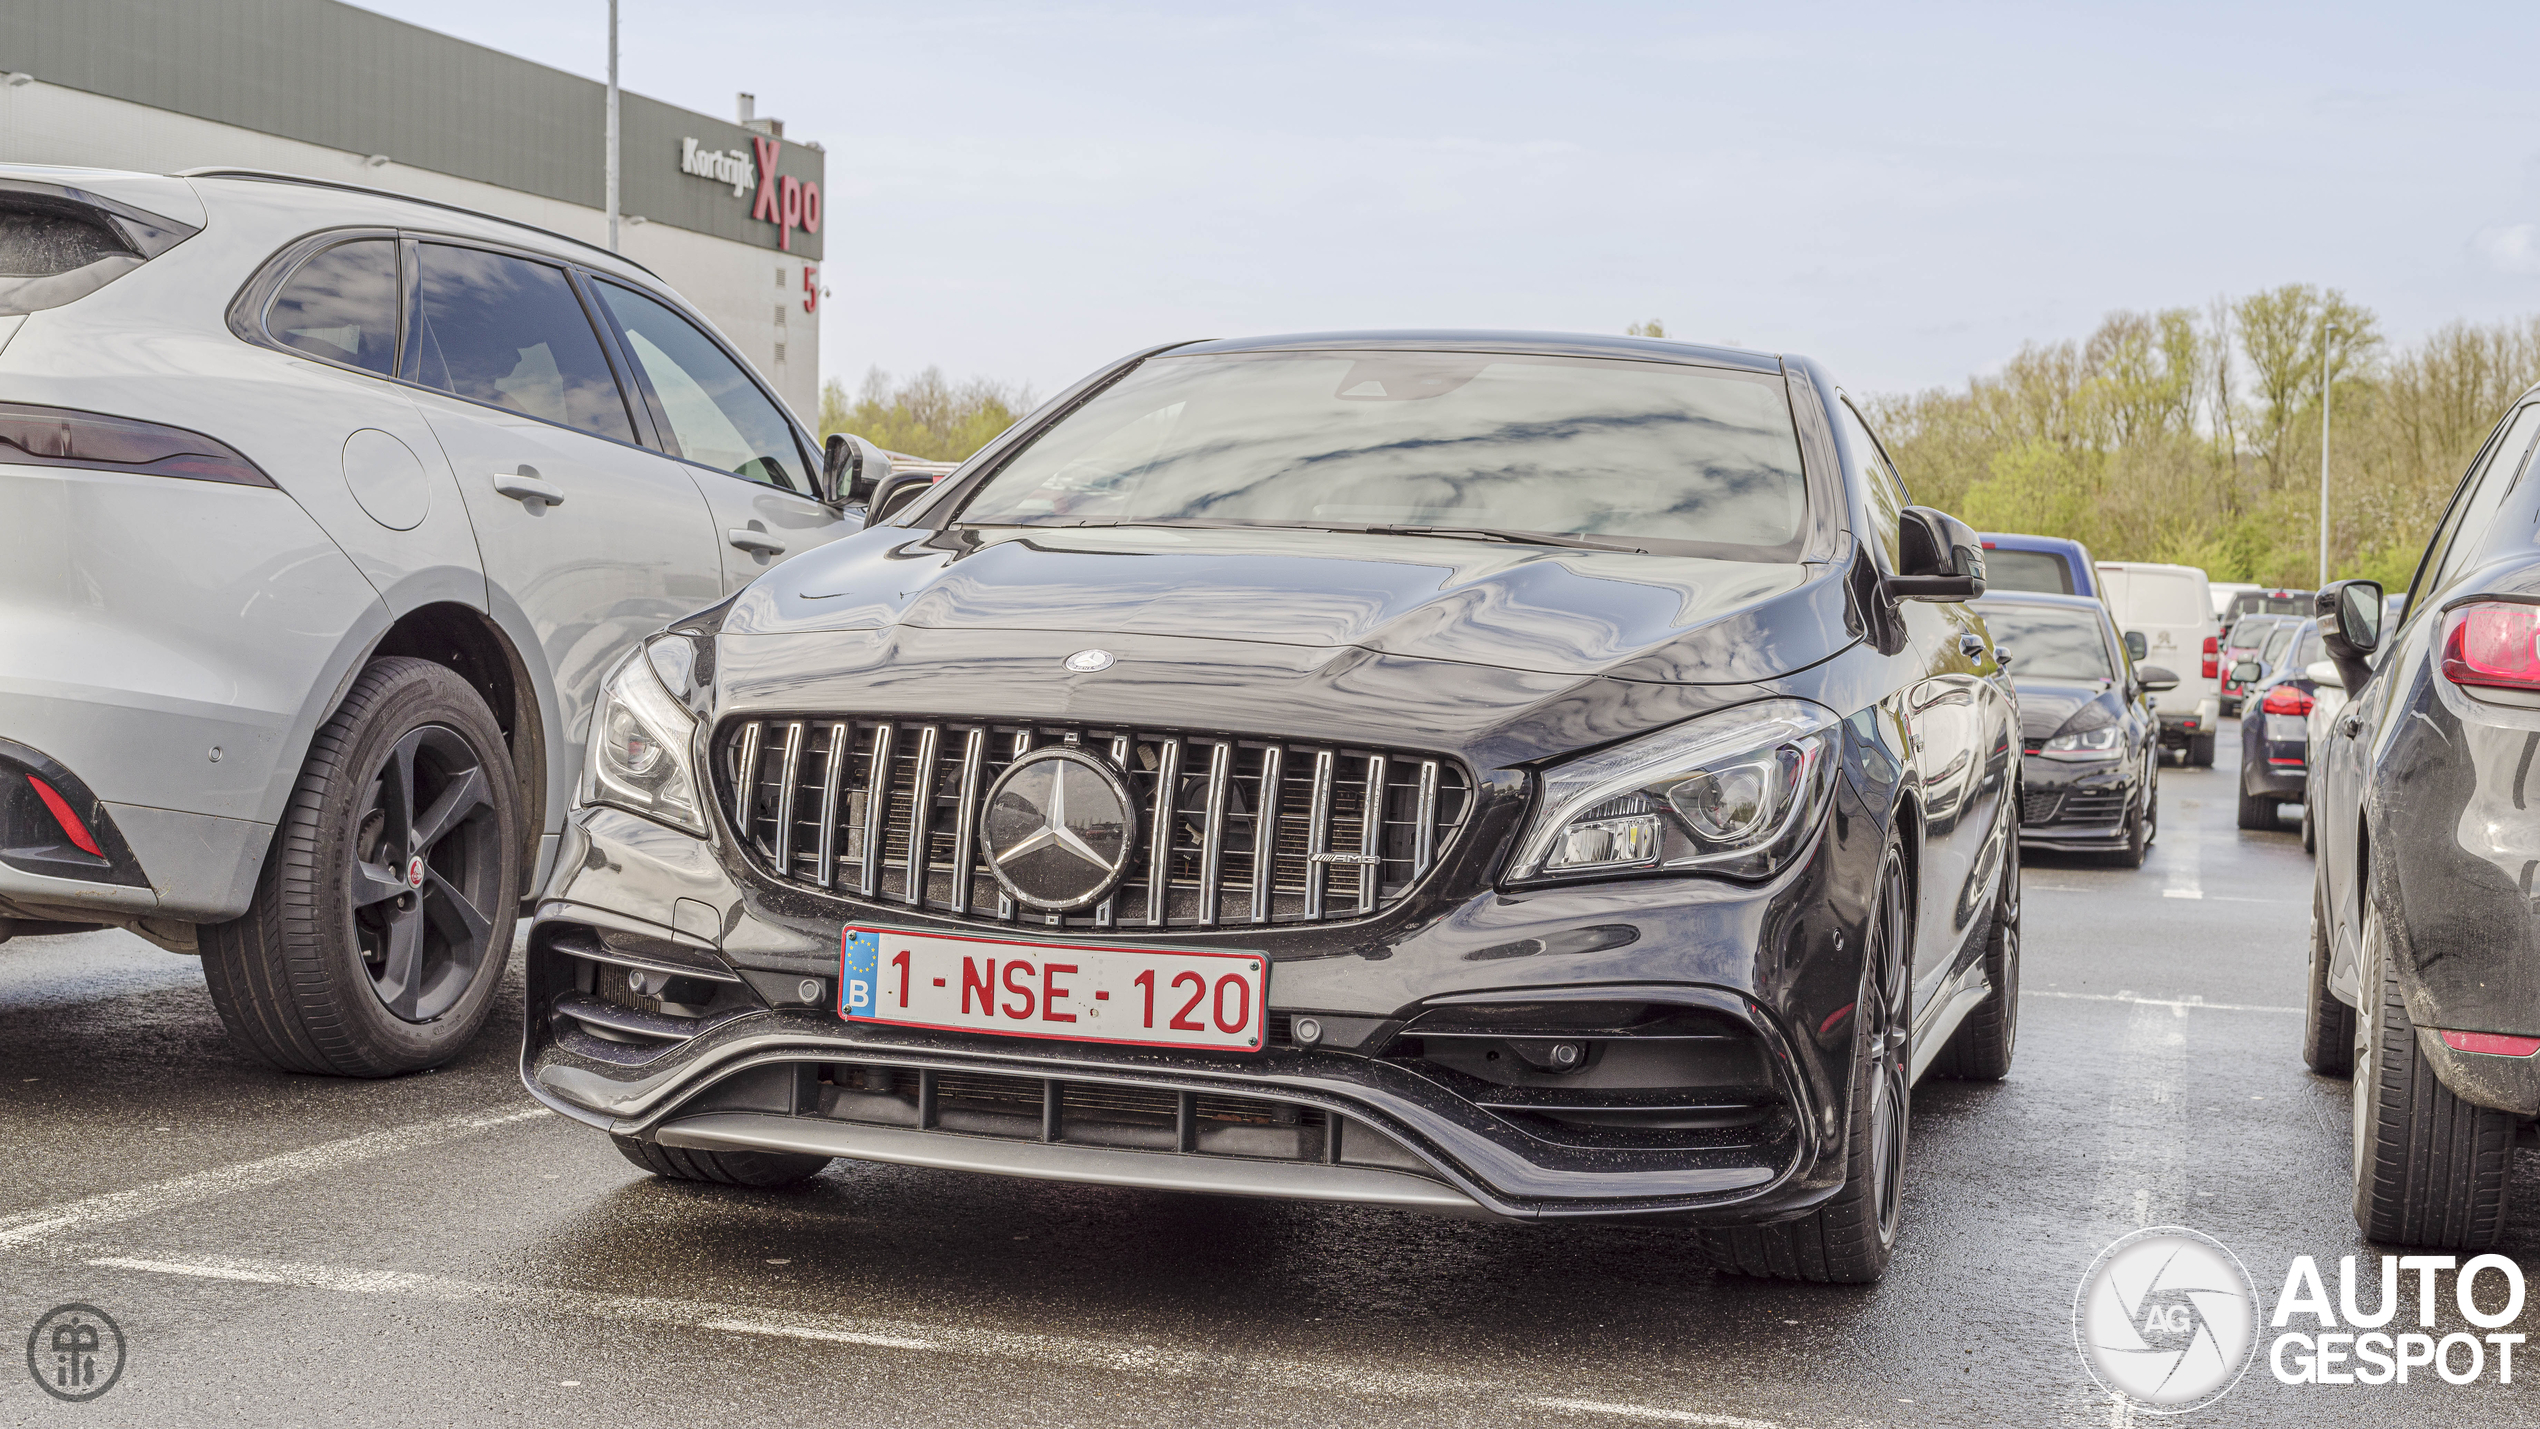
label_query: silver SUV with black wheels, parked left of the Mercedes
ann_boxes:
[0,165,894,1076]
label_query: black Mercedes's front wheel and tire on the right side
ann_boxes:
[1697,848,1913,1284]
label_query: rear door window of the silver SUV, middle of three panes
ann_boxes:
[409,244,635,442]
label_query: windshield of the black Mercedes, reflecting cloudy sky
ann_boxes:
[960,353,1808,561]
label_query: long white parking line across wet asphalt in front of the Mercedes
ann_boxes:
[84,1246,1783,1429]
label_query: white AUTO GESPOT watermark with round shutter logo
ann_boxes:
[2073,1226,2525,1414]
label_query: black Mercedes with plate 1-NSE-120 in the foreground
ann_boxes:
[523,333,2019,1282]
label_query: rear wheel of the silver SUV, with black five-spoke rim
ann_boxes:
[201,657,521,1076]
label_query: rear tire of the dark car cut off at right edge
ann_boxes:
[2355,896,2515,1251]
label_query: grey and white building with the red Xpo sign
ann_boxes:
[0,0,828,424]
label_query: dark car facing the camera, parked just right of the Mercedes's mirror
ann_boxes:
[1976,591,2179,868]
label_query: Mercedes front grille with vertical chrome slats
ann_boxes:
[714,713,1473,932]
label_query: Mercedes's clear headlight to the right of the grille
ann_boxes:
[1509,701,1836,881]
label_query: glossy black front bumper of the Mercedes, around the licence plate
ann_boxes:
[521,810,1875,1223]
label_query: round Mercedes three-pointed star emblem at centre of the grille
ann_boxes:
[978,744,1130,911]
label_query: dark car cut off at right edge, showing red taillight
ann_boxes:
[2304,388,2540,1249]
